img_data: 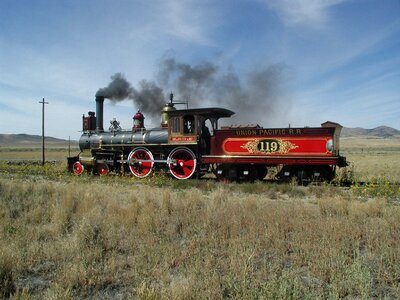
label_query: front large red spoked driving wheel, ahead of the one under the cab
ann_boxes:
[128,147,154,178]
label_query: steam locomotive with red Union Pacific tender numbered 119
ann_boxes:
[68,94,347,182]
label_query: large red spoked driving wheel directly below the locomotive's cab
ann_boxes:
[168,147,196,179]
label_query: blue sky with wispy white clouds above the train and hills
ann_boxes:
[0,0,400,139]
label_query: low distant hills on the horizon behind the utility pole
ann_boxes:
[0,133,77,147]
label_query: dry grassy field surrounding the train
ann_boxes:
[0,139,400,299]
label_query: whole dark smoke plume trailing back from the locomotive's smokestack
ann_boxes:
[96,57,290,125]
